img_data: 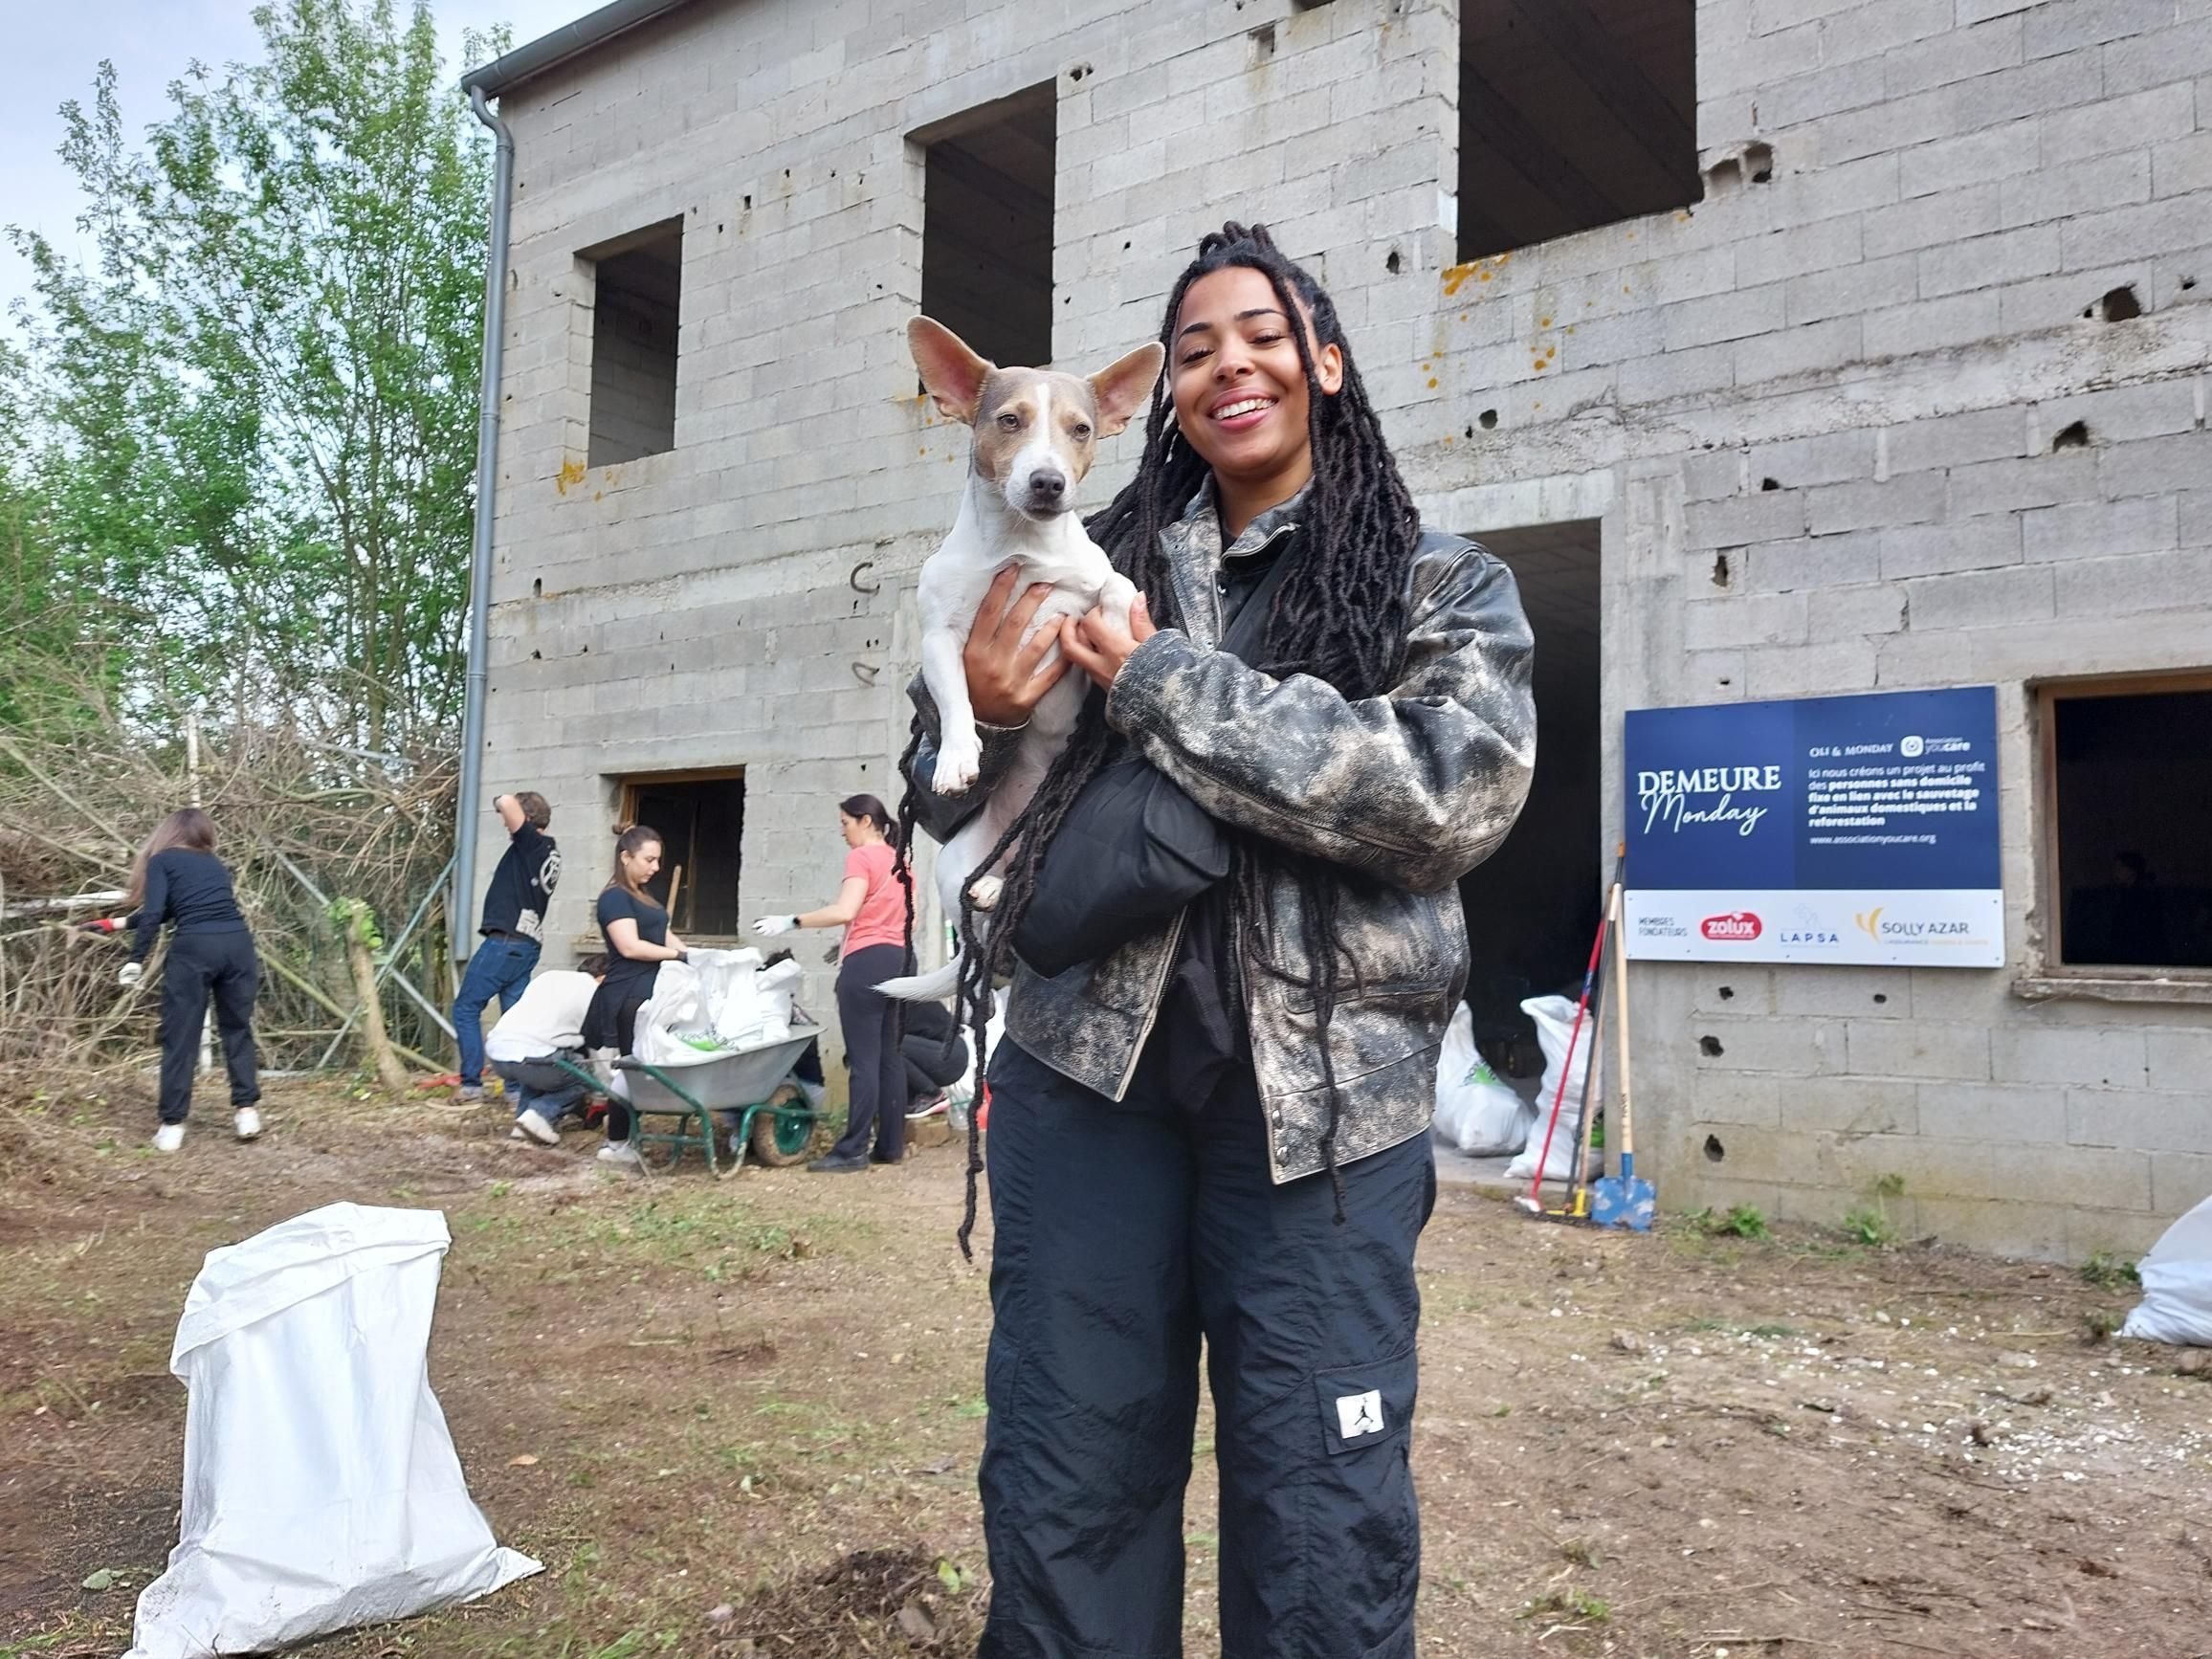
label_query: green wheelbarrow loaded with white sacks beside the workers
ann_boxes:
[558,1027,821,1175]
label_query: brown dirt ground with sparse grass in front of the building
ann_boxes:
[0,1082,2212,1659]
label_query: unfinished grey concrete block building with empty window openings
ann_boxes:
[471,0,2212,1259]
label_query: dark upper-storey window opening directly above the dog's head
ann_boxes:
[912,82,1059,365]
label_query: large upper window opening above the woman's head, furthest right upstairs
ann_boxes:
[1460,0,1701,259]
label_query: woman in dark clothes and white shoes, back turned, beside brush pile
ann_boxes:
[91,807,261,1153]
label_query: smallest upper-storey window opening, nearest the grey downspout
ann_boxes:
[577,219,683,467]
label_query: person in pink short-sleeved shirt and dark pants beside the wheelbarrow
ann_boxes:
[752,794,907,1175]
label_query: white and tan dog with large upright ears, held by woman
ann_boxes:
[878,317,1165,1002]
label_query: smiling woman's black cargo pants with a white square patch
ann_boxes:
[978,1042,1435,1659]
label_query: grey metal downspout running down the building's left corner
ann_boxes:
[445,86,516,962]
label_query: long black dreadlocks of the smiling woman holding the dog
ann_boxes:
[909,221,1420,1252]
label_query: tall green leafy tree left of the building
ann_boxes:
[0,0,504,750]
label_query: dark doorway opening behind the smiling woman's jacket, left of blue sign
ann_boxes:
[1460,520,1610,1083]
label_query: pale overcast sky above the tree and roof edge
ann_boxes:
[0,0,600,317]
